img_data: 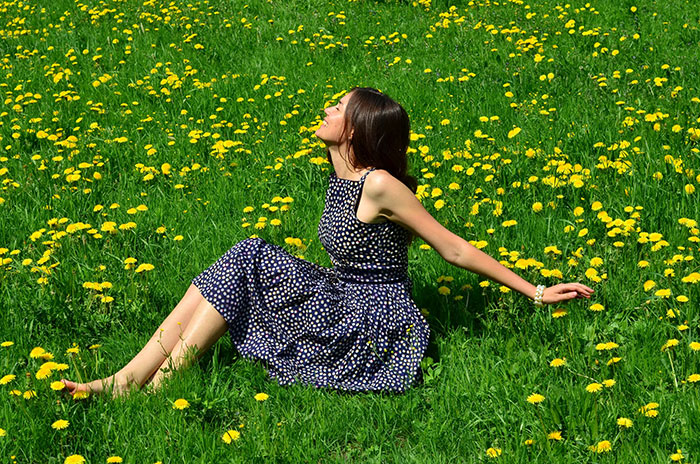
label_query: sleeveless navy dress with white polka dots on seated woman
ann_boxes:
[192,168,429,392]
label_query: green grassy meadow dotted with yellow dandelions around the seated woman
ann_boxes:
[0,0,700,464]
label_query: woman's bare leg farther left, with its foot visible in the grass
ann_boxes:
[63,284,204,394]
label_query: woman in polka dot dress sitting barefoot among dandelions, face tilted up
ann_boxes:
[64,88,593,394]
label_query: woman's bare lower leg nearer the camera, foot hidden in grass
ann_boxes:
[149,298,228,388]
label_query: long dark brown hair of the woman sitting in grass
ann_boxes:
[328,87,418,193]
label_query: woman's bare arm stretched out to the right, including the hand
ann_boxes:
[365,169,593,304]
